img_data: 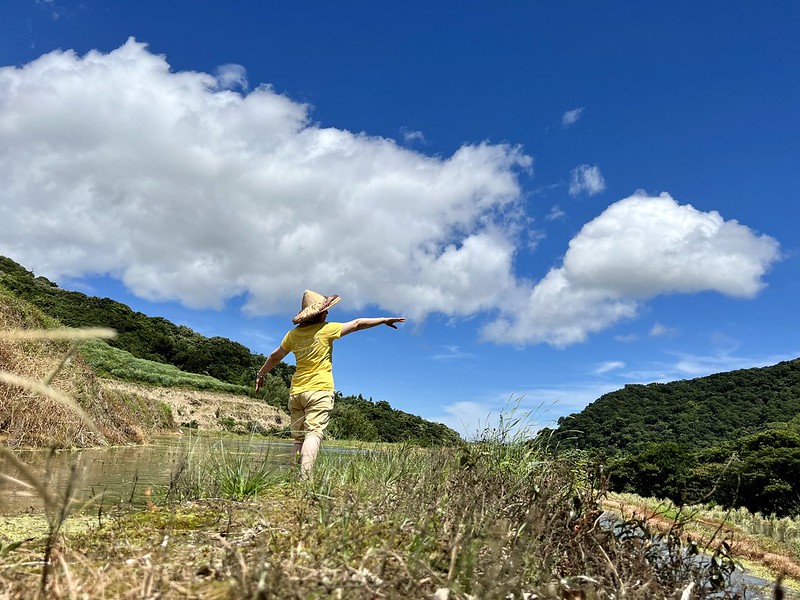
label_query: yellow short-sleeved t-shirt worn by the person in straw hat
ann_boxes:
[281,323,342,394]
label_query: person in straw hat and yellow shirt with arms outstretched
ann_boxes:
[256,290,405,477]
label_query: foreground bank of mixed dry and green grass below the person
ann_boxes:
[0,440,792,600]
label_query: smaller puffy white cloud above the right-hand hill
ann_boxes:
[483,193,779,346]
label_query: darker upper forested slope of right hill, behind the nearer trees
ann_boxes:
[555,359,800,454]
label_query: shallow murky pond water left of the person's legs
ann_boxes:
[0,433,292,515]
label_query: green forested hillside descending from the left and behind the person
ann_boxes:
[0,256,461,446]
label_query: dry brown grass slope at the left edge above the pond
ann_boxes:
[0,288,172,448]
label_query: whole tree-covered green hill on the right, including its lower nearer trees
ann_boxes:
[546,359,800,517]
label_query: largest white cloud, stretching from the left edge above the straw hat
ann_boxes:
[0,39,531,318]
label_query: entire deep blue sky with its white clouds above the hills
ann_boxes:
[0,0,800,435]
